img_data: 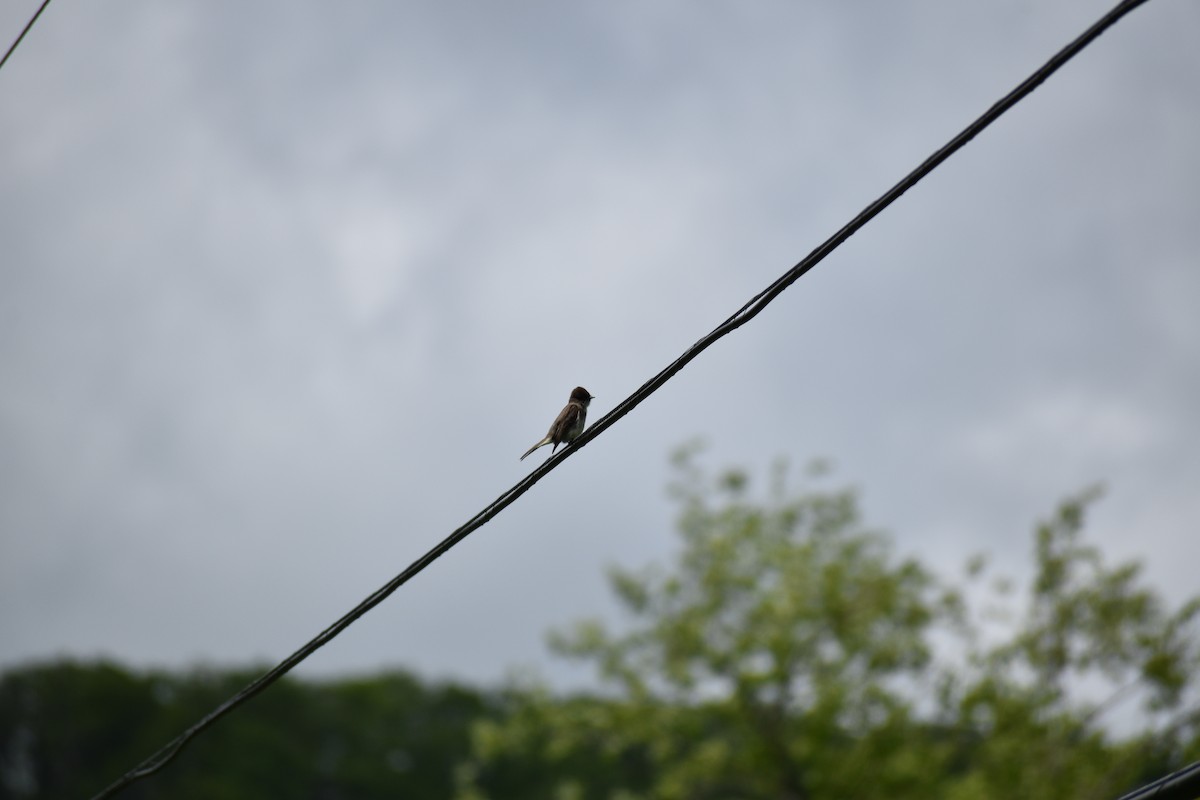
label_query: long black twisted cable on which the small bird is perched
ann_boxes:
[92,0,1146,800]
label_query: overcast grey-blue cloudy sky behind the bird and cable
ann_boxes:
[0,0,1200,681]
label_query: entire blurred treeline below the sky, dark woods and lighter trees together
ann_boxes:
[0,451,1200,800]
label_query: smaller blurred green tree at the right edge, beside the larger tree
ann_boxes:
[941,489,1200,800]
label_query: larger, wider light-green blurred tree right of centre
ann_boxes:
[464,450,955,800]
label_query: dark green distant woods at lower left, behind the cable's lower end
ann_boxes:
[0,662,494,800]
